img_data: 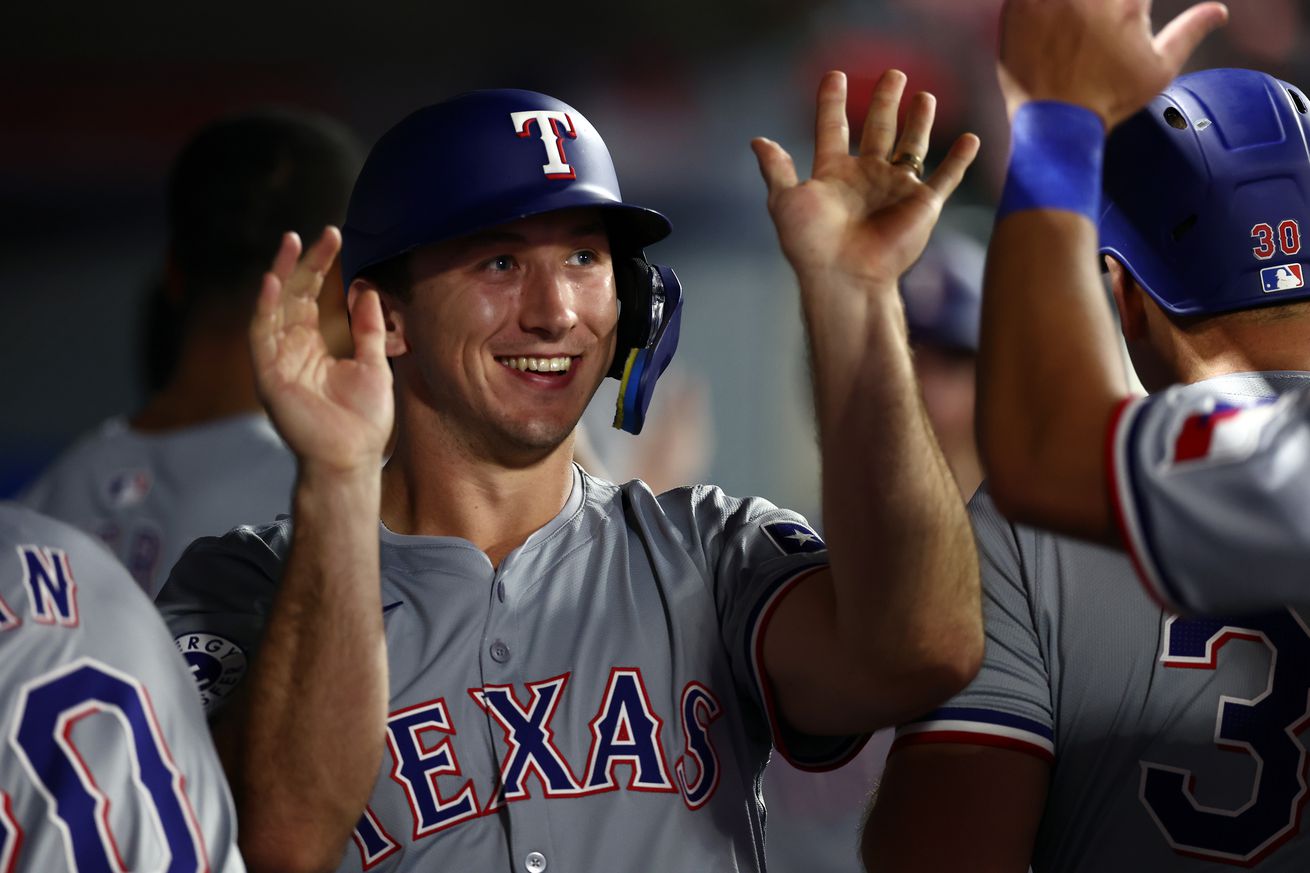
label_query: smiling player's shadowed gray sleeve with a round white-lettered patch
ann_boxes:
[155,519,291,716]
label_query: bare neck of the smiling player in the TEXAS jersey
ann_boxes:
[381,425,572,566]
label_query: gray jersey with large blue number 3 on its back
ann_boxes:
[893,489,1310,873]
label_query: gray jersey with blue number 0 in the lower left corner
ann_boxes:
[0,503,245,873]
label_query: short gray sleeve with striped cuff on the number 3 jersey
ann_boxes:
[892,486,1055,762]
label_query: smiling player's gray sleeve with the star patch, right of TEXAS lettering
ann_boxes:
[665,488,869,769]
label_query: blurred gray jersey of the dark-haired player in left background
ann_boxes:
[21,414,296,598]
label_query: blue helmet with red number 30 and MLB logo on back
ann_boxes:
[1100,69,1310,316]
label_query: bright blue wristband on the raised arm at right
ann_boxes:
[996,100,1106,223]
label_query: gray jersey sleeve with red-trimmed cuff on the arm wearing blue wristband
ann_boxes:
[1110,372,1310,612]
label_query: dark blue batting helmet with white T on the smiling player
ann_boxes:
[341,89,683,434]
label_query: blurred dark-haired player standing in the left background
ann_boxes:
[21,110,360,596]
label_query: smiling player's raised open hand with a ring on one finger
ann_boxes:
[751,69,979,290]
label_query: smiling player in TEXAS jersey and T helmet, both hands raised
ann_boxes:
[160,72,981,873]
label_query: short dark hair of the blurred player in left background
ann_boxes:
[168,109,363,302]
